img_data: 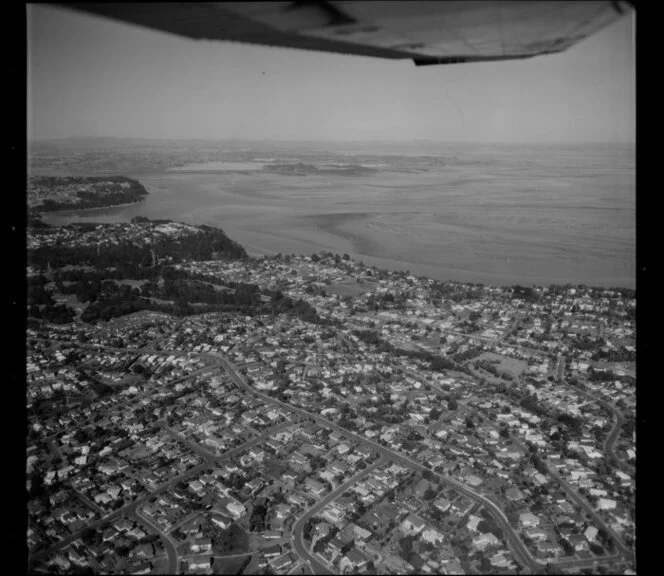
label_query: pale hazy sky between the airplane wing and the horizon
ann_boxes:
[27,4,635,142]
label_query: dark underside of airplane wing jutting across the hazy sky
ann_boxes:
[58,0,632,66]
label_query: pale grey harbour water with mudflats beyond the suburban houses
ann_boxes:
[39,145,636,287]
